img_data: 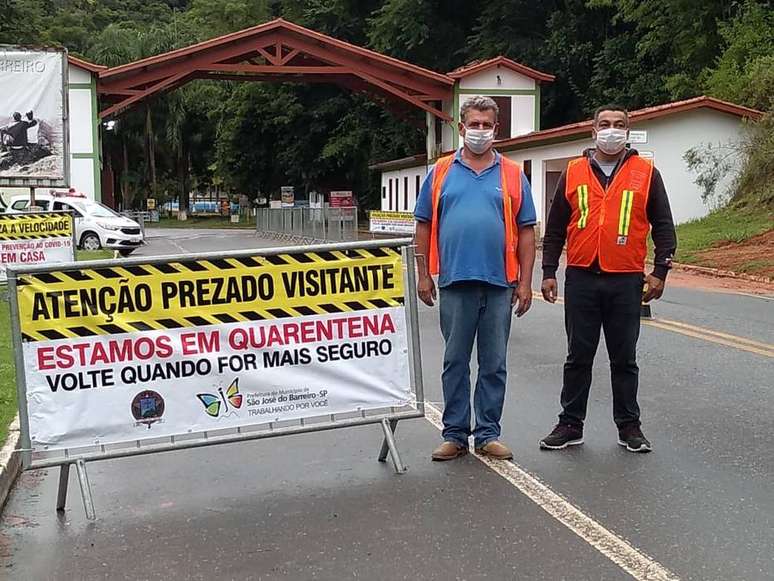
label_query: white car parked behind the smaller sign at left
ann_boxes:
[5,193,144,256]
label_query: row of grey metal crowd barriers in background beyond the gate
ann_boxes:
[255,207,358,244]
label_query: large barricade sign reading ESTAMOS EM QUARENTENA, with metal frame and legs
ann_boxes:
[9,240,424,518]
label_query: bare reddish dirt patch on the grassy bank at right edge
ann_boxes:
[696,229,774,278]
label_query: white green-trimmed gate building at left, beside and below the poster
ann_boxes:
[0,56,105,205]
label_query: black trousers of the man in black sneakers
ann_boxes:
[559,267,644,427]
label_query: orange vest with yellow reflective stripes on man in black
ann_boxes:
[564,155,653,272]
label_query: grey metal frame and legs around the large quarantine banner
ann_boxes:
[8,239,425,520]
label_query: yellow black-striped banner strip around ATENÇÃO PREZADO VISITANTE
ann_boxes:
[17,247,404,341]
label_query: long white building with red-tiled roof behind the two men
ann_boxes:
[371,90,760,231]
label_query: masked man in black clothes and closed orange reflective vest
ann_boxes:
[540,105,677,452]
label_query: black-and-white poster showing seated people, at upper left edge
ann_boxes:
[0,46,68,186]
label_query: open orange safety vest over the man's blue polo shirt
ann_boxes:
[429,154,521,283]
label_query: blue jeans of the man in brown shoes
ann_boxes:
[440,281,513,448]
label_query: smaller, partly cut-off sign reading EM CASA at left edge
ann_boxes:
[0,212,75,282]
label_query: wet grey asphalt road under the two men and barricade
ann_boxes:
[0,230,774,581]
